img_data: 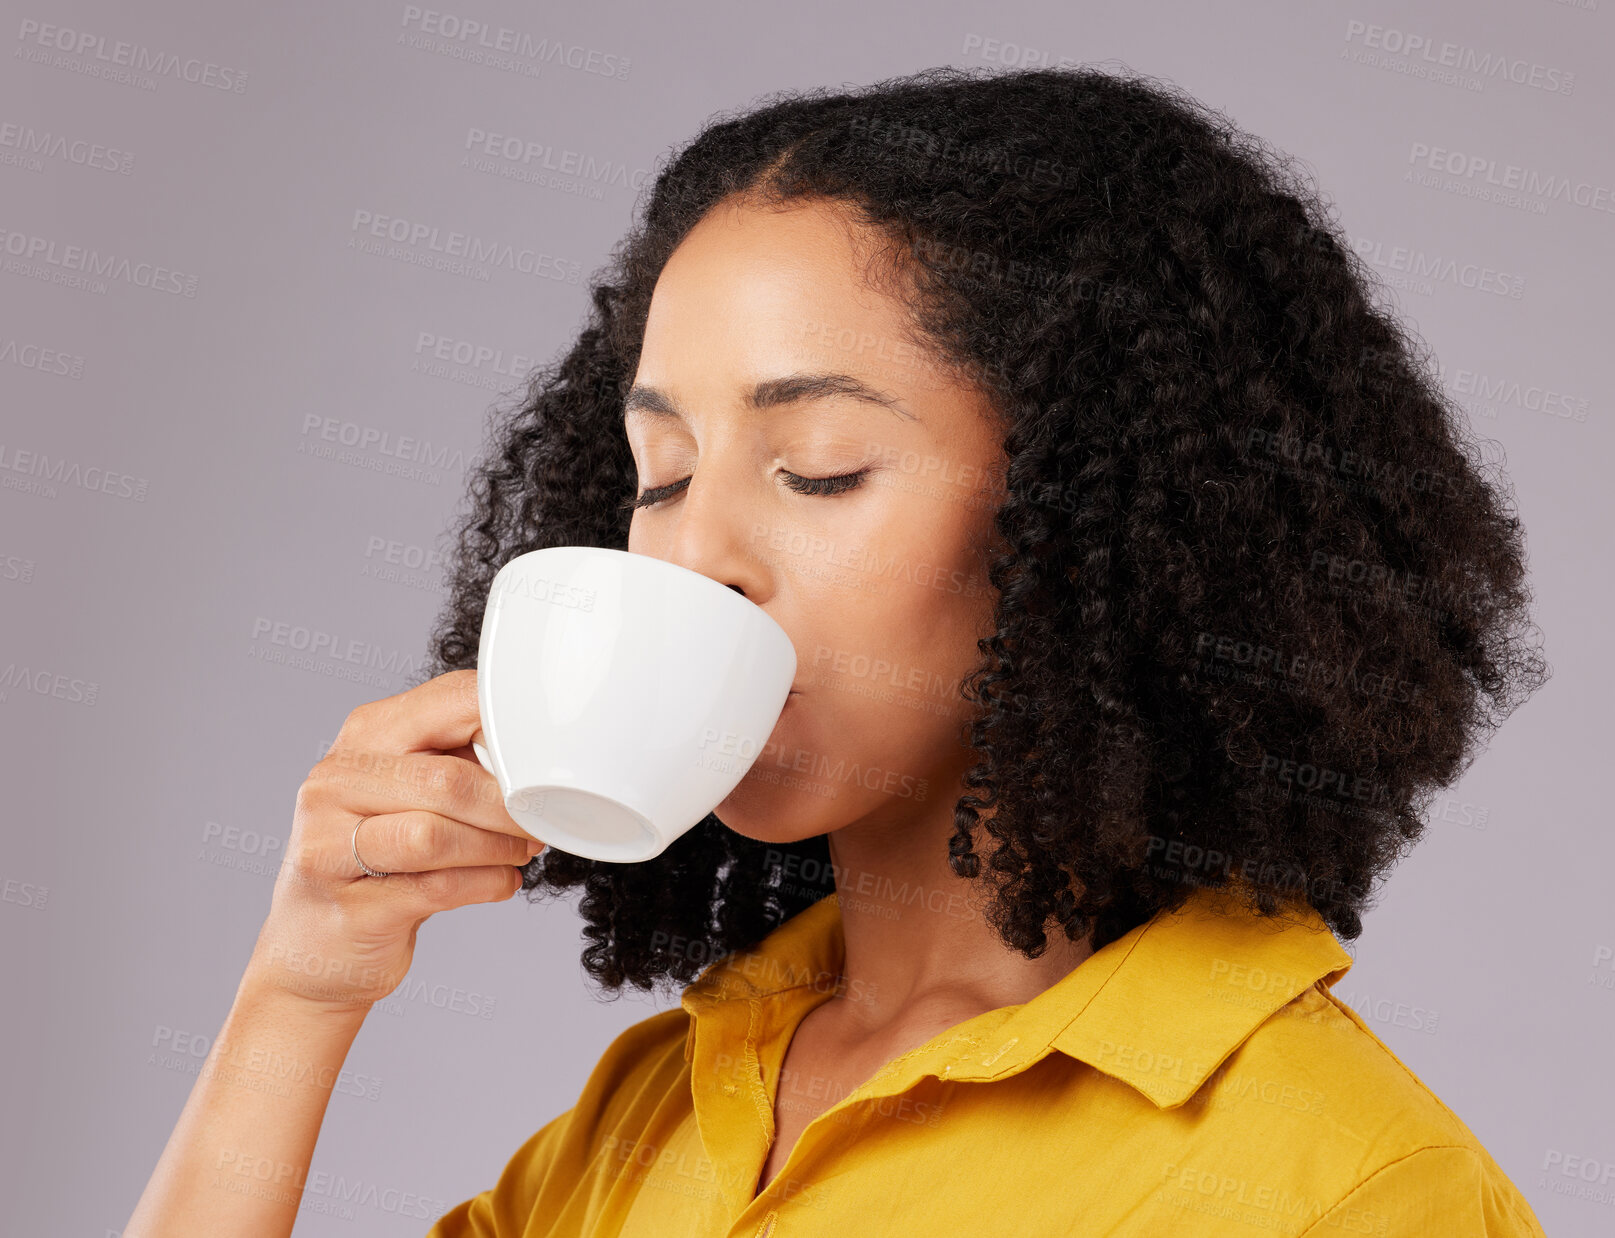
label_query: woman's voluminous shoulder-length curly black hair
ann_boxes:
[425,66,1547,991]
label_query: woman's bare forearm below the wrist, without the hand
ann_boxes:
[123,978,365,1238]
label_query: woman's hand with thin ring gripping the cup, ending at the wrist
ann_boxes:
[247,670,544,1010]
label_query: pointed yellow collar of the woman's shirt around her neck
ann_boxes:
[682,886,1352,1109]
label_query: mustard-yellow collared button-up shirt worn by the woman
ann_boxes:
[428,889,1542,1238]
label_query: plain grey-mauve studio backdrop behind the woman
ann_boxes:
[0,0,1615,1238]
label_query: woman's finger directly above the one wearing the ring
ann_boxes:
[308,747,531,839]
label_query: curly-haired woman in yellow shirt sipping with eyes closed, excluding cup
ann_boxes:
[126,69,1546,1238]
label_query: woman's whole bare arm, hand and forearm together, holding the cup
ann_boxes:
[123,670,543,1238]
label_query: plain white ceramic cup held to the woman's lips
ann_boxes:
[473,546,796,864]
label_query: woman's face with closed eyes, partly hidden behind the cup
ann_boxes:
[625,193,1005,843]
